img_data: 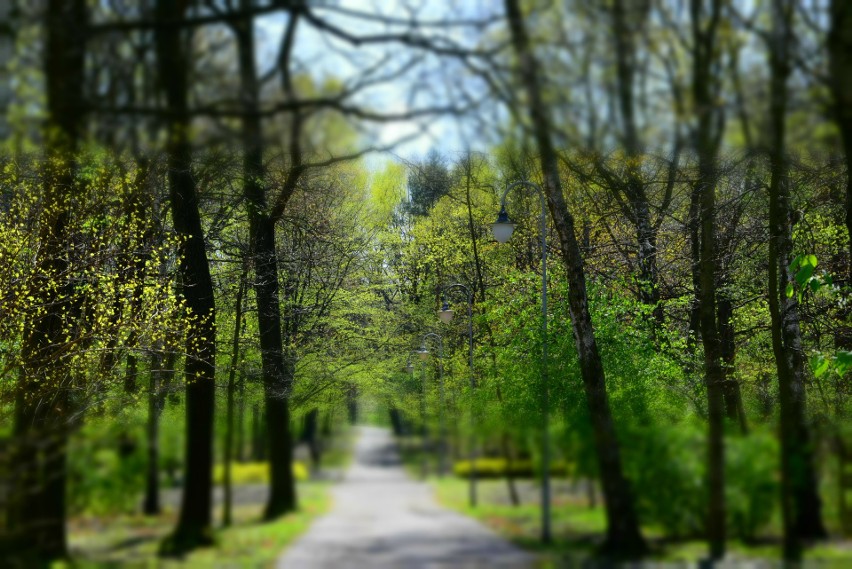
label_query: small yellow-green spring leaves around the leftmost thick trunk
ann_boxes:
[0,152,185,408]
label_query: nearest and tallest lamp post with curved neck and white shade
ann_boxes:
[491,180,551,543]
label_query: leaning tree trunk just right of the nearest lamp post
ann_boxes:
[505,0,647,557]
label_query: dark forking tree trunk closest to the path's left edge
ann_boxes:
[234,8,296,520]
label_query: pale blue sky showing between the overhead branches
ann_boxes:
[257,0,501,166]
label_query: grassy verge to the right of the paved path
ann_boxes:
[430,478,852,569]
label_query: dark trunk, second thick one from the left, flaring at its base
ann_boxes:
[156,0,216,554]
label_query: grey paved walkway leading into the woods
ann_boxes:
[277,427,535,569]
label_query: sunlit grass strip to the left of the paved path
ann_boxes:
[55,482,330,569]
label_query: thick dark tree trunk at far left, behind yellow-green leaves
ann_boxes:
[8,0,86,564]
